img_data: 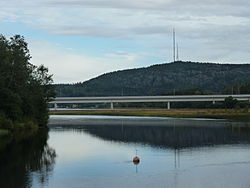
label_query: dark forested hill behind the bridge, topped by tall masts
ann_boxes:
[56,61,250,97]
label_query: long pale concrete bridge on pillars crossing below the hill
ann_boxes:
[50,94,250,109]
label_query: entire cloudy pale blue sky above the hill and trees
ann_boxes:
[0,0,250,83]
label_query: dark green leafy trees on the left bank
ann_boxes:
[0,35,54,129]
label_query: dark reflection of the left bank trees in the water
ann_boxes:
[0,130,56,188]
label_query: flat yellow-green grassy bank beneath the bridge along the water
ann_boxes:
[49,109,250,121]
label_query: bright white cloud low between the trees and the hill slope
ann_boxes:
[29,41,142,83]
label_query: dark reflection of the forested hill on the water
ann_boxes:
[52,121,250,149]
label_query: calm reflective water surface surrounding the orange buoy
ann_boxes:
[0,116,250,188]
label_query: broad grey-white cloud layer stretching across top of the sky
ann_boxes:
[0,0,250,40]
